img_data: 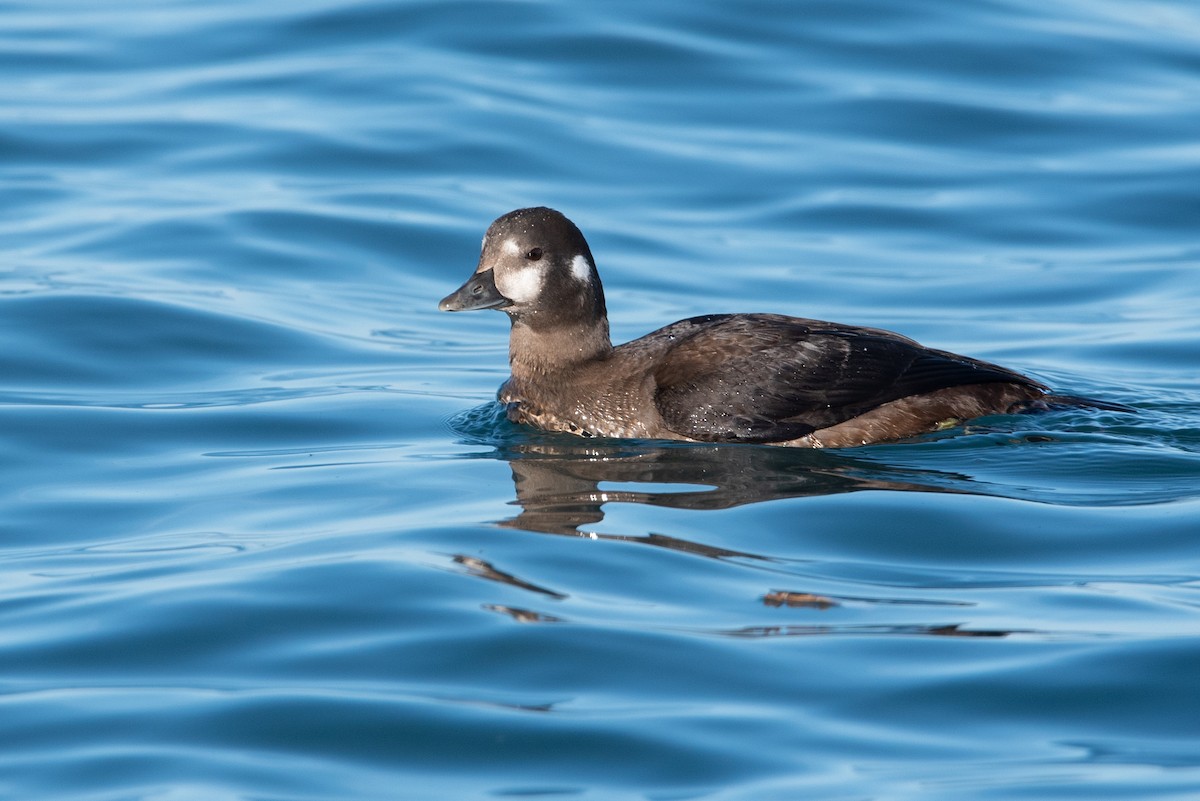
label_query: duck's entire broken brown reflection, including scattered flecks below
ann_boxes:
[455,438,1012,638]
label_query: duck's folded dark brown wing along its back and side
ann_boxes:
[654,314,1044,442]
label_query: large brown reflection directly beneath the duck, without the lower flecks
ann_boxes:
[498,442,978,537]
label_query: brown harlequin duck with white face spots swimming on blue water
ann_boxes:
[438,207,1116,447]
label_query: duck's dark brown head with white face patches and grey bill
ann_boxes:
[438,207,608,338]
